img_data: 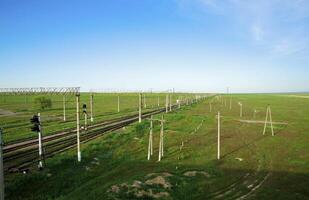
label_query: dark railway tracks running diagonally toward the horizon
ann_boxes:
[3,105,178,172]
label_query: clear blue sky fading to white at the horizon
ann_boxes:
[0,0,309,92]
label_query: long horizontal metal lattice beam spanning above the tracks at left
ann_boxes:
[0,87,80,95]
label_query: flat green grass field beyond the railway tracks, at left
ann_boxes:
[0,93,193,143]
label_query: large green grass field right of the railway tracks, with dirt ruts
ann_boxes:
[5,94,309,200]
